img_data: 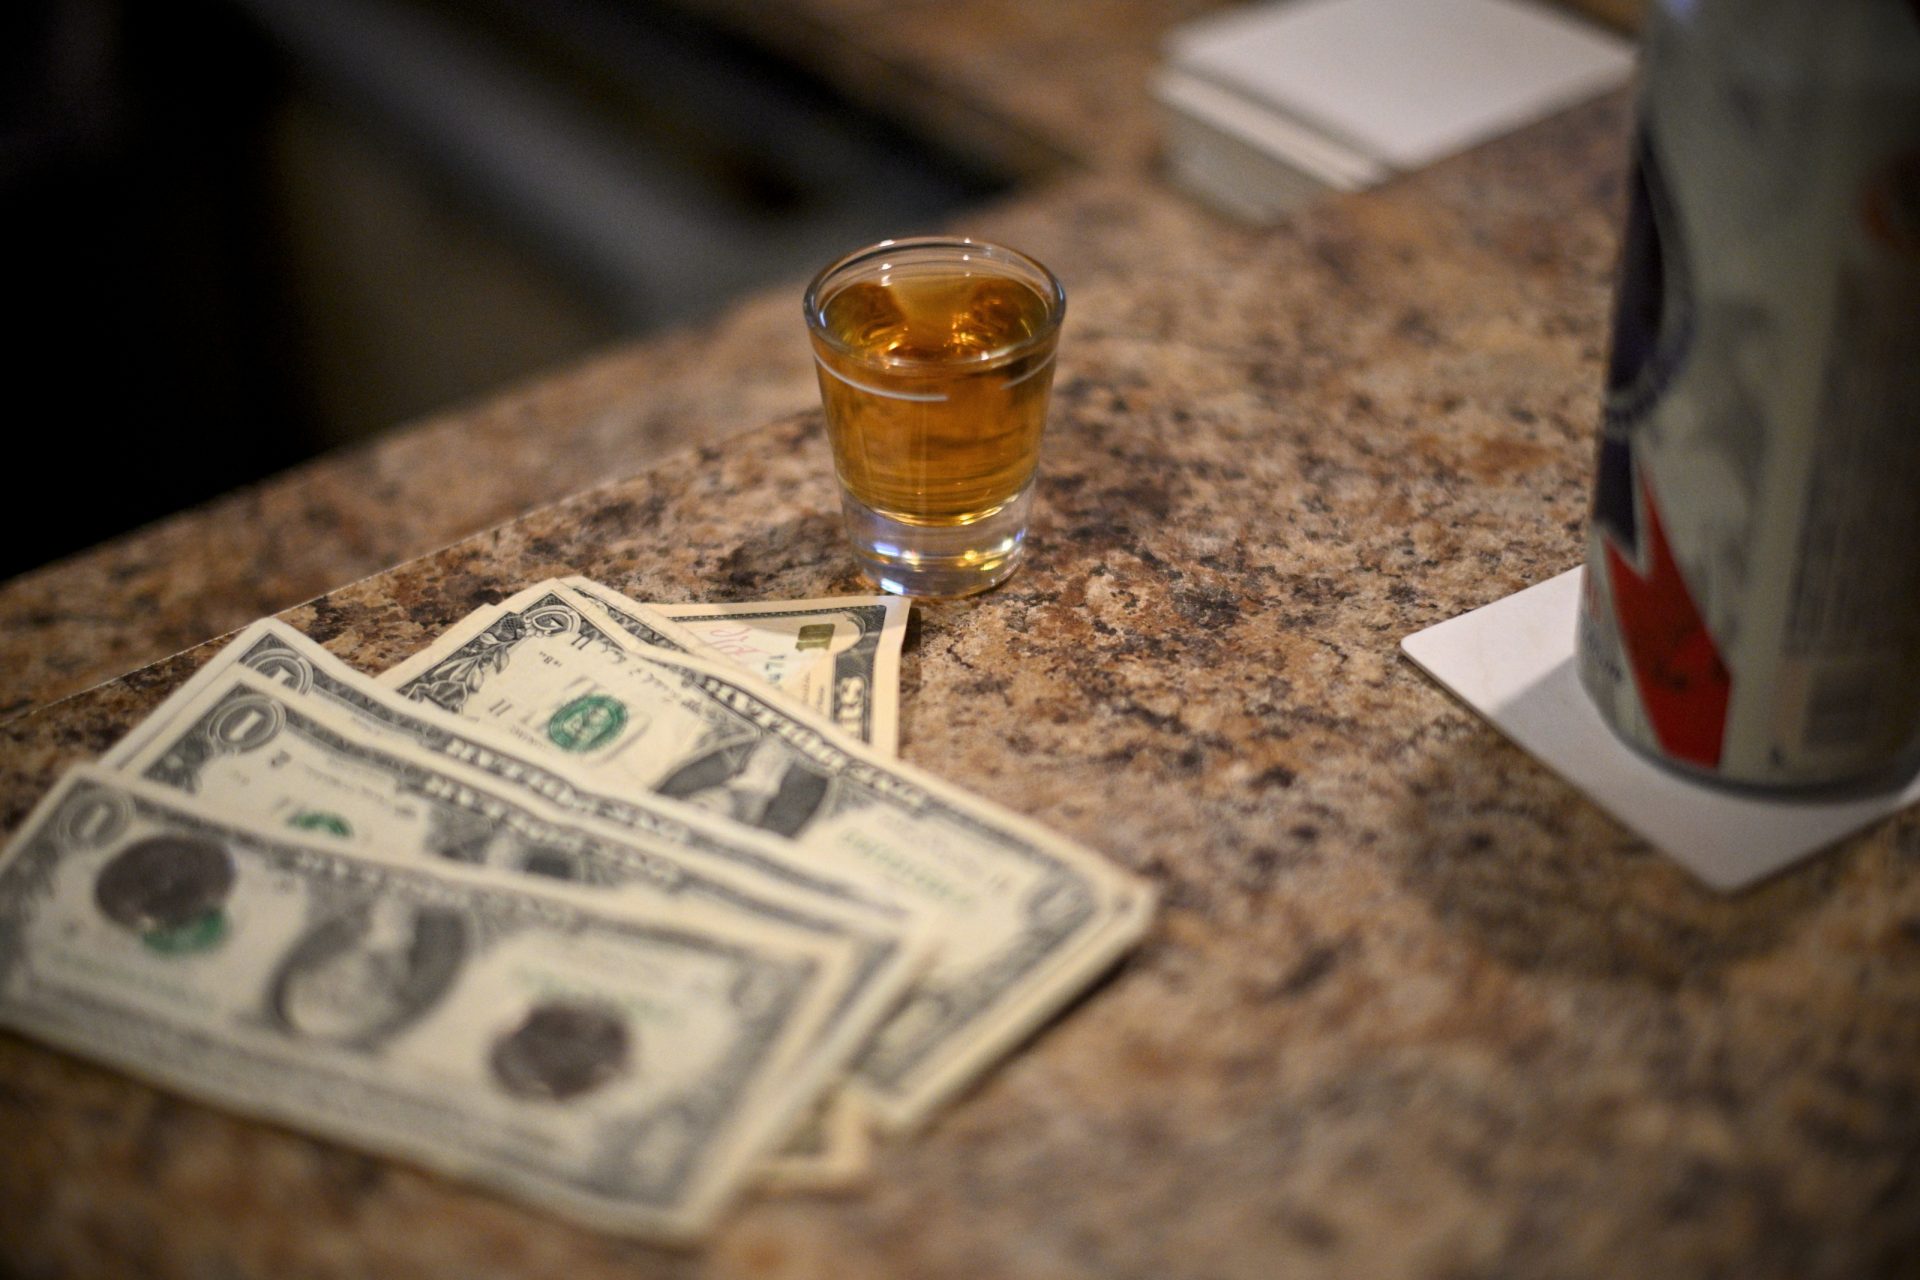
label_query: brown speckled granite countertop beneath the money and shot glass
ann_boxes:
[0,5,1920,1280]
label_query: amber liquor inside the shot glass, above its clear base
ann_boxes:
[814,271,1056,528]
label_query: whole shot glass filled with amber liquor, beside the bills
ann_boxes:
[806,236,1068,597]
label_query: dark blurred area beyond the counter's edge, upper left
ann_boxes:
[0,0,1008,578]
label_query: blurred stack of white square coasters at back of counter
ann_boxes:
[1154,0,1634,223]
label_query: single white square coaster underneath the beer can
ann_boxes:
[1400,568,1920,890]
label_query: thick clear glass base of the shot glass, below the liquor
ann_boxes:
[841,482,1033,597]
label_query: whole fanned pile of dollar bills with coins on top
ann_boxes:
[0,578,1152,1242]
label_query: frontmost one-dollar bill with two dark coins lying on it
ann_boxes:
[0,768,856,1240]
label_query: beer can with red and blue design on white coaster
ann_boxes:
[1578,0,1920,787]
